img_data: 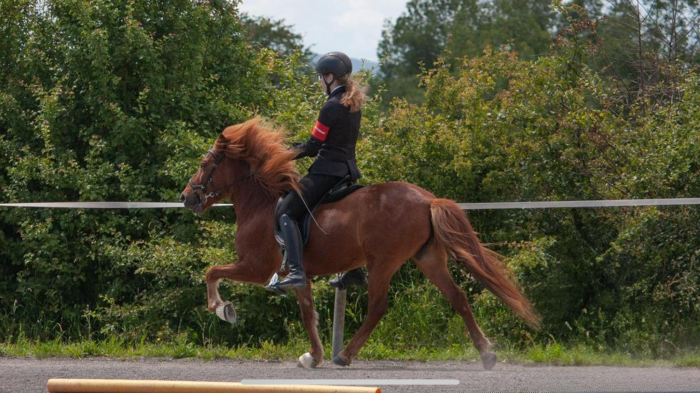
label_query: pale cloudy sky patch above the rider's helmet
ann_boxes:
[240,0,408,61]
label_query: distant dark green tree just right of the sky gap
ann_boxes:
[375,0,554,103]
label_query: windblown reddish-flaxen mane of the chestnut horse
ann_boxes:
[214,117,299,196]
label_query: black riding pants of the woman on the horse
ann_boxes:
[275,173,343,222]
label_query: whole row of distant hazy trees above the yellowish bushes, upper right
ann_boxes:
[374,0,700,107]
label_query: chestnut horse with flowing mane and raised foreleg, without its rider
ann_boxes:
[181,119,539,369]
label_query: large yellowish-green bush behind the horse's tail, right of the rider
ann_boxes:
[363,4,700,355]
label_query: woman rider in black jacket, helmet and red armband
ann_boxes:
[269,52,366,290]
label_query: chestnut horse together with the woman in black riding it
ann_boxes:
[181,52,540,369]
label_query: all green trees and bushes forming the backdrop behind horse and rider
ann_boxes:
[0,0,700,356]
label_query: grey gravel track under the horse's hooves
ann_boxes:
[0,358,700,393]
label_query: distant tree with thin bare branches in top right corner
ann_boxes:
[587,0,700,104]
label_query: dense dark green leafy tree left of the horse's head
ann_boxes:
[0,0,274,338]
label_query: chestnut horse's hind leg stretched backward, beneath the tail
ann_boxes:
[416,241,496,370]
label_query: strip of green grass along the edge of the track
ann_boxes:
[0,340,700,367]
